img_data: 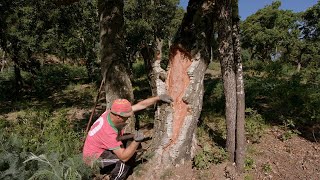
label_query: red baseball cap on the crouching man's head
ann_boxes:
[111,99,133,117]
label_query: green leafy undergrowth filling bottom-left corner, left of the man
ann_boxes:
[0,109,92,179]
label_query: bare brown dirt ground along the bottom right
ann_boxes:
[128,127,320,180]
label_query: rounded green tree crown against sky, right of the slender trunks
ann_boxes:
[241,1,297,61]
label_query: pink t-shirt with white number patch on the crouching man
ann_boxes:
[83,111,122,164]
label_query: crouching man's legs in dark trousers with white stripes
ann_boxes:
[100,151,130,180]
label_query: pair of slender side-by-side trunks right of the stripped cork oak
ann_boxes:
[216,0,245,172]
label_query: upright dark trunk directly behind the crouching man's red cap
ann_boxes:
[98,0,134,131]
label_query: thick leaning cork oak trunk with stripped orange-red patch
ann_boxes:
[144,0,214,179]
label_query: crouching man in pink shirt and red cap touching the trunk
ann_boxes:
[83,94,172,179]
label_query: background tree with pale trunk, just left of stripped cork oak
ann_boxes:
[125,0,183,96]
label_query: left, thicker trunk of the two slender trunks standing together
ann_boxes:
[217,0,237,162]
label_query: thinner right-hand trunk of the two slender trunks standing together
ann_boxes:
[232,0,246,172]
